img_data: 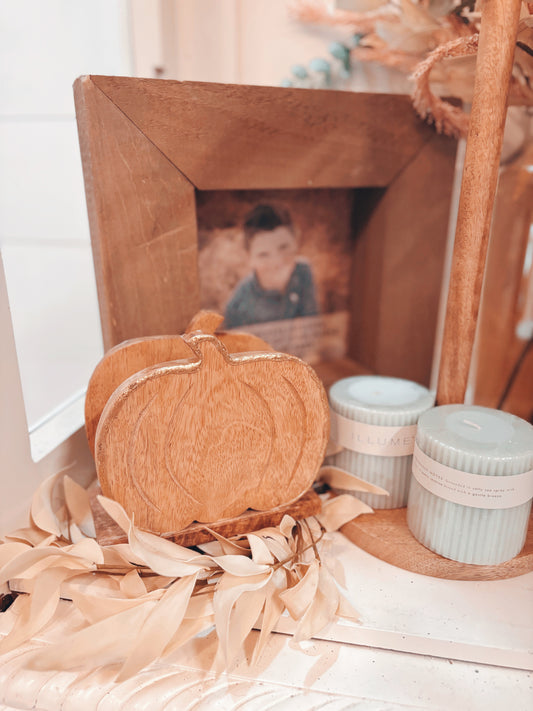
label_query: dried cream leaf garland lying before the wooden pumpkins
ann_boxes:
[0,474,378,680]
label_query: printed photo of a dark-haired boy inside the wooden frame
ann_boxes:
[196,189,353,363]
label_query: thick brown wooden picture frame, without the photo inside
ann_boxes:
[74,76,456,383]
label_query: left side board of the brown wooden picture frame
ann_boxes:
[74,77,200,350]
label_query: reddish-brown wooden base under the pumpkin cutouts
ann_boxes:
[90,487,321,547]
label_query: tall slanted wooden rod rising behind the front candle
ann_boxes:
[437,0,521,405]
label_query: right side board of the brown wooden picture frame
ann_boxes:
[349,135,456,385]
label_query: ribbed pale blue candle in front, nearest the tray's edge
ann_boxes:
[407,405,533,565]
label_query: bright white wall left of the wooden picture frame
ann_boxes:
[0,0,131,426]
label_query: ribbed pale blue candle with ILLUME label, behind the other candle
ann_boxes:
[329,375,434,509]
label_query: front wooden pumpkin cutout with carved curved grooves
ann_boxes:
[95,333,329,533]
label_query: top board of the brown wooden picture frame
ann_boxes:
[90,76,432,190]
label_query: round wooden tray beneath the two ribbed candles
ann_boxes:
[341,509,533,580]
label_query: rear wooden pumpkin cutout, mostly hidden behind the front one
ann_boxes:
[85,311,272,454]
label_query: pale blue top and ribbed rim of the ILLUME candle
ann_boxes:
[329,375,434,426]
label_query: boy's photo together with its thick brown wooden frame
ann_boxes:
[74,76,456,383]
